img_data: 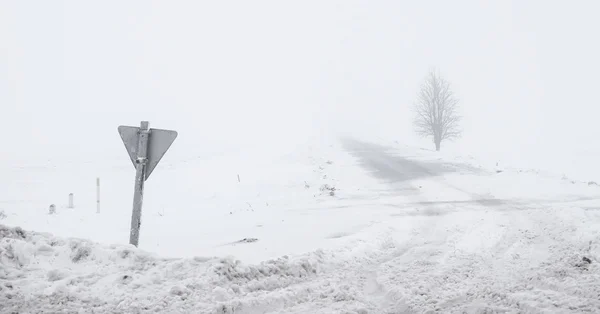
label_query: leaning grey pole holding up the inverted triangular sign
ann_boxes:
[129,121,150,246]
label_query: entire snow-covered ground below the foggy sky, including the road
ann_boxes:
[0,139,600,313]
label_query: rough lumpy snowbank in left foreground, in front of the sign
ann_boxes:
[0,225,324,313]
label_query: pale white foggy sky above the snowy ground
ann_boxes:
[0,0,600,164]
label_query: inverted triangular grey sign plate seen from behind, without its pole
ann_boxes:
[119,125,177,180]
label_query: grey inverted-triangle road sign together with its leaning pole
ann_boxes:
[119,121,177,246]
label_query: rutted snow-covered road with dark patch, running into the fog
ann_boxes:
[286,141,600,313]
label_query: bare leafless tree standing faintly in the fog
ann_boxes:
[414,70,461,151]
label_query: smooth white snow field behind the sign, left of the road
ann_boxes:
[0,137,376,262]
